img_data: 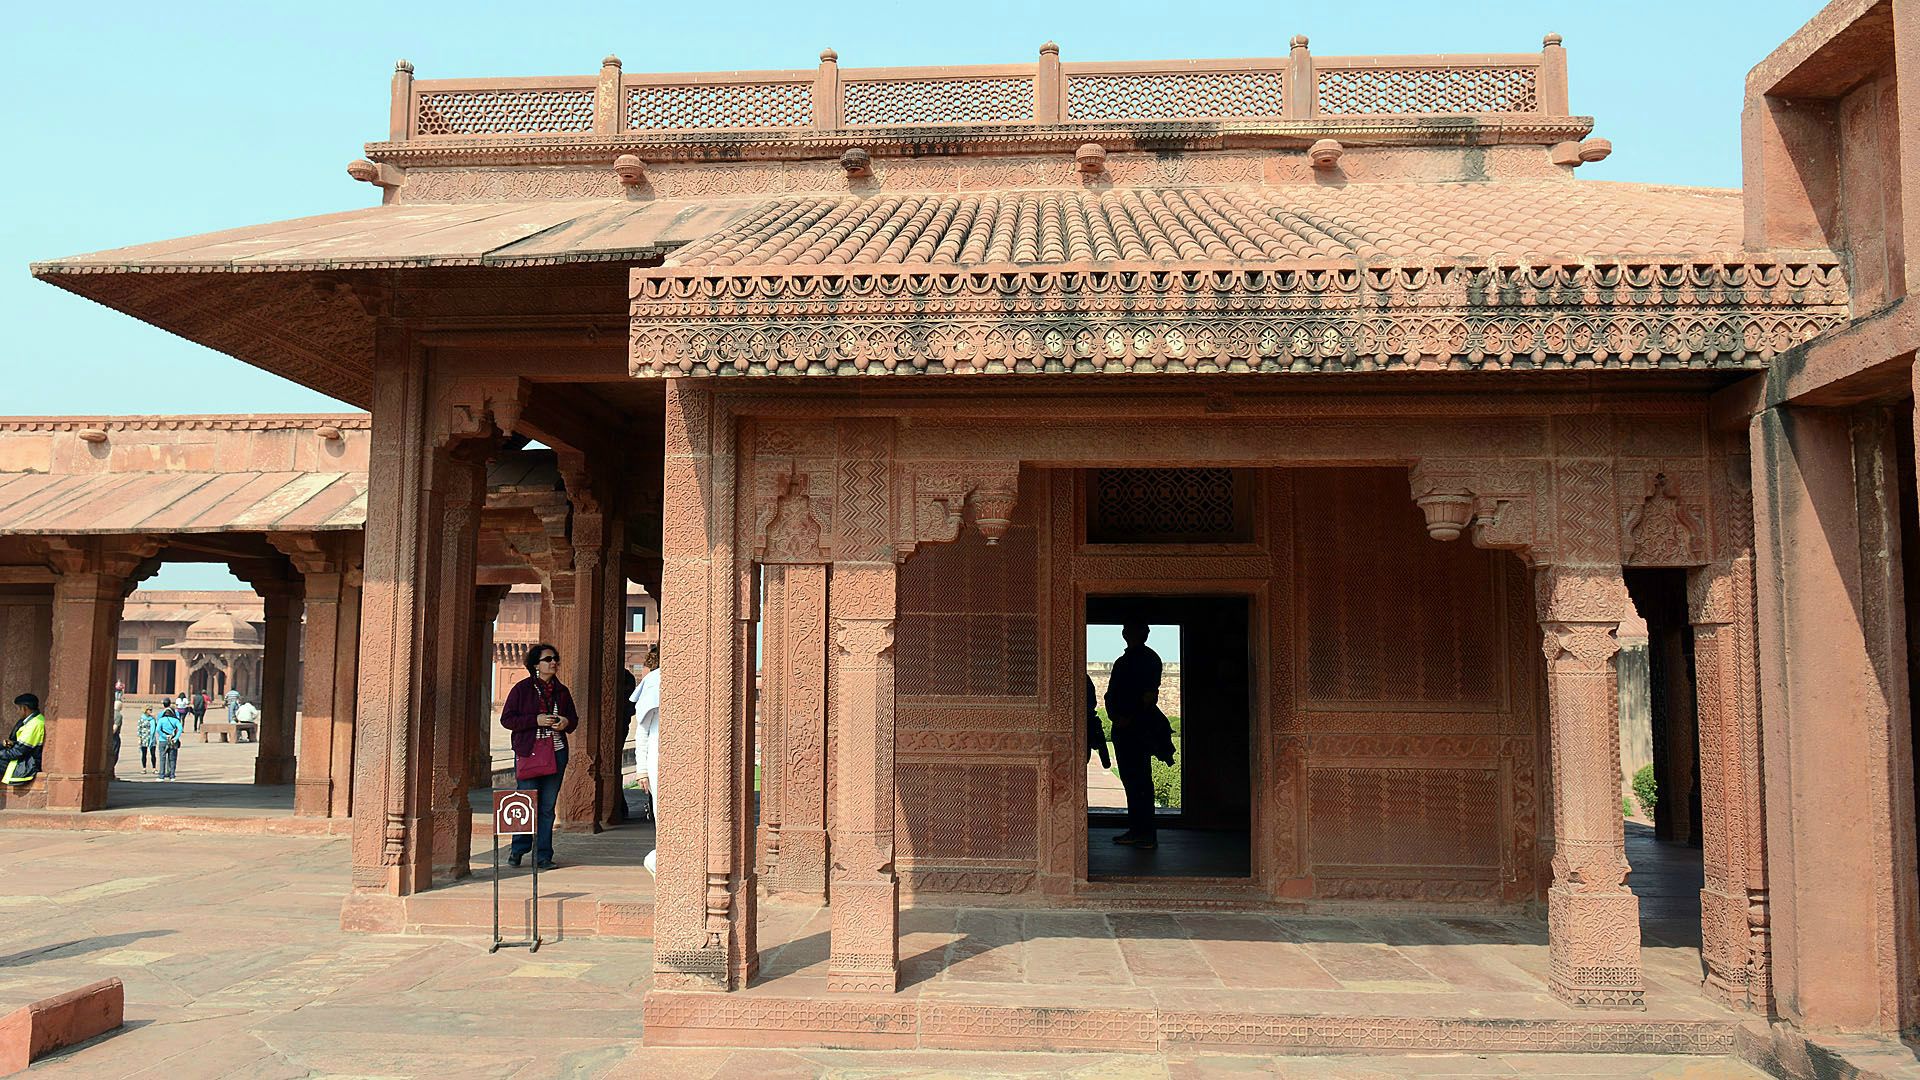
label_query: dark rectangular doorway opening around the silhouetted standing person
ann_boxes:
[1087,596,1254,880]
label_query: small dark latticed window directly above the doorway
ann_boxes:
[1087,469,1254,544]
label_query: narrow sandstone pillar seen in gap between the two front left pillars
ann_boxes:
[762,563,829,903]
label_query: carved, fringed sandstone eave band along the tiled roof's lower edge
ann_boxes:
[628,258,1849,377]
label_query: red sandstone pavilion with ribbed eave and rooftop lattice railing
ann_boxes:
[0,0,1920,1047]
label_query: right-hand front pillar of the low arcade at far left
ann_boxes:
[269,532,361,817]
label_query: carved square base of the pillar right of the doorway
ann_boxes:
[1548,884,1647,1009]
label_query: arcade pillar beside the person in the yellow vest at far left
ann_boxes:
[41,538,159,811]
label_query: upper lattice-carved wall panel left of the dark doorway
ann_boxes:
[893,527,1041,698]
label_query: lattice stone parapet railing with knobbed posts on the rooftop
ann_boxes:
[390,35,1567,142]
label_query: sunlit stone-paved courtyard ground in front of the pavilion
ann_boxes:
[0,818,1759,1080]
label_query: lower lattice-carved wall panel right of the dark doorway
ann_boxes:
[1308,767,1503,872]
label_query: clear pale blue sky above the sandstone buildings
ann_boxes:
[0,0,1820,588]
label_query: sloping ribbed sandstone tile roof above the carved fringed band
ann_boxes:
[657,181,1741,269]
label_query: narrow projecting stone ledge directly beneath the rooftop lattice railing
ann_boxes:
[365,113,1594,169]
